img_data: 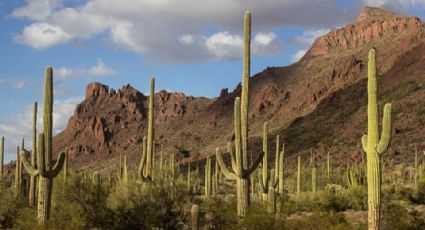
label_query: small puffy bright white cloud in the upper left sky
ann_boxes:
[14,23,72,49]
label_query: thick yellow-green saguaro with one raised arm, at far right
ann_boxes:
[362,49,391,230]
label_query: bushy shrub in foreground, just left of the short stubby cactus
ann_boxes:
[109,177,191,229]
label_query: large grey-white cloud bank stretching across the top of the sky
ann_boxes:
[12,0,356,62]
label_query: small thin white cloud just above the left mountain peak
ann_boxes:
[55,58,116,79]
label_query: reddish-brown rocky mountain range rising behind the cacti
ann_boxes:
[54,7,425,172]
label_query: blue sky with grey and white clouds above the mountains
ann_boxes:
[0,0,425,163]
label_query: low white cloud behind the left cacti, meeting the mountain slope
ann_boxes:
[0,97,83,159]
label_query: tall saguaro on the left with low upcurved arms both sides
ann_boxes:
[21,66,66,224]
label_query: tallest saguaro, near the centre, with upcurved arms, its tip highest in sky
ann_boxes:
[216,11,263,217]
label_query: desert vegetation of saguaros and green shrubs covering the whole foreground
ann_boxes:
[0,12,425,230]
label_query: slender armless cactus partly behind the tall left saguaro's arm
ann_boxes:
[28,102,37,207]
